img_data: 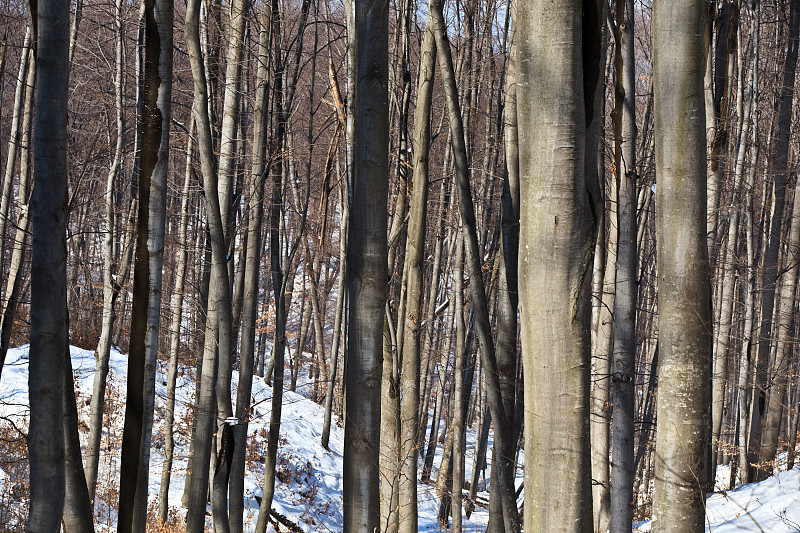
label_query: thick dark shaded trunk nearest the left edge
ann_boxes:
[26,0,69,533]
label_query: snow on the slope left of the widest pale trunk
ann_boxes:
[0,346,500,532]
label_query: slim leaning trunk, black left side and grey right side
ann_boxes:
[118,0,173,533]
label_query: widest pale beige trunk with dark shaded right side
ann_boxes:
[515,2,603,531]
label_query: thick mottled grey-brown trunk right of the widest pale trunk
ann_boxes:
[653,0,711,532]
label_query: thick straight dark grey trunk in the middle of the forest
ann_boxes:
[343,0,389,533]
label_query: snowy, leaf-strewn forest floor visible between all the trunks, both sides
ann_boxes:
[0,346,800,533]
